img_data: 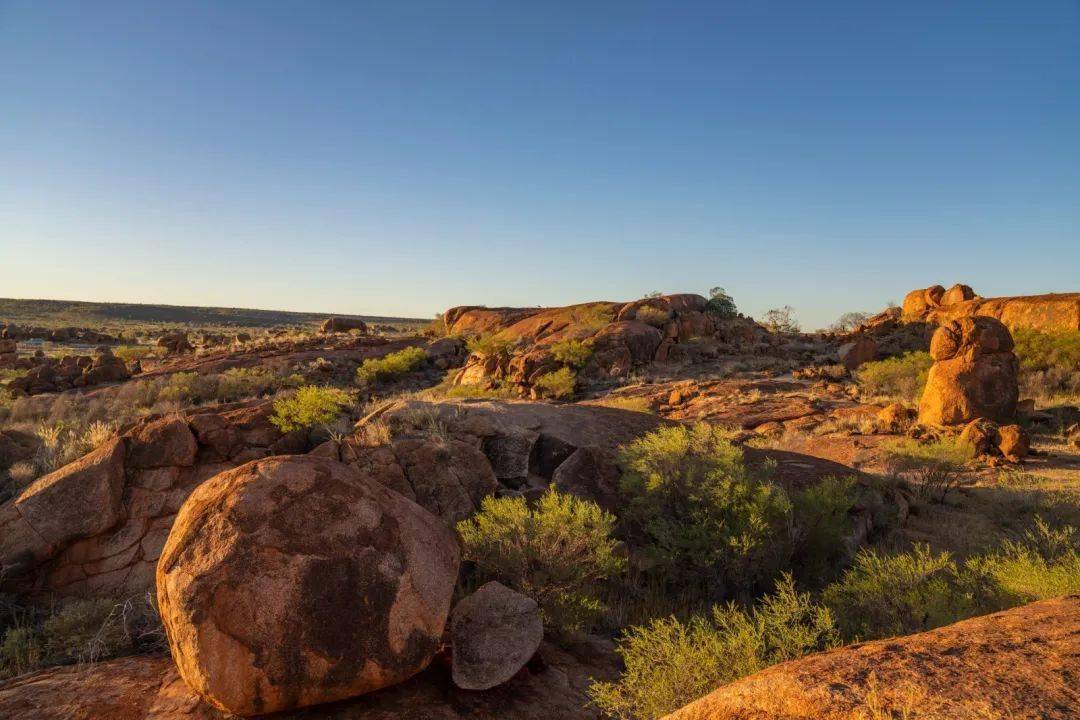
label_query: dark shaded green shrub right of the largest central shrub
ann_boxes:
[788,477,855,584]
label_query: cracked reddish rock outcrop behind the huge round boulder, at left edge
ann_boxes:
[0,400,311,597]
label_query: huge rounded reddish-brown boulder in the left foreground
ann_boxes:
[157,456,460,716]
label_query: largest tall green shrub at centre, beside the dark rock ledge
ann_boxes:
[619,423,791,589]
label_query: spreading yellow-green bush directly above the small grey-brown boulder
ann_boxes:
[458,488,625,634]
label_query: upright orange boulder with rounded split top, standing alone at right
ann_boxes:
[919,317,1020,425]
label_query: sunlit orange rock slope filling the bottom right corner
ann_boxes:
[667,596,1080,720]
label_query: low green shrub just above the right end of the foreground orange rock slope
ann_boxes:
[822,545,974,640]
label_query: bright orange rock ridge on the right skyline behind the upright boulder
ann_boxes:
[903,285,1080,332]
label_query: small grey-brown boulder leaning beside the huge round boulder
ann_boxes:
[450,582,543,690]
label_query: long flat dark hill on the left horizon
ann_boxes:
[0,298,430,327]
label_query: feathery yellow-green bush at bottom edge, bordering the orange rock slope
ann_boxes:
[589,576,838,720]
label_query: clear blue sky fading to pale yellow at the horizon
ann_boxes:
[0,0,1080,327]
